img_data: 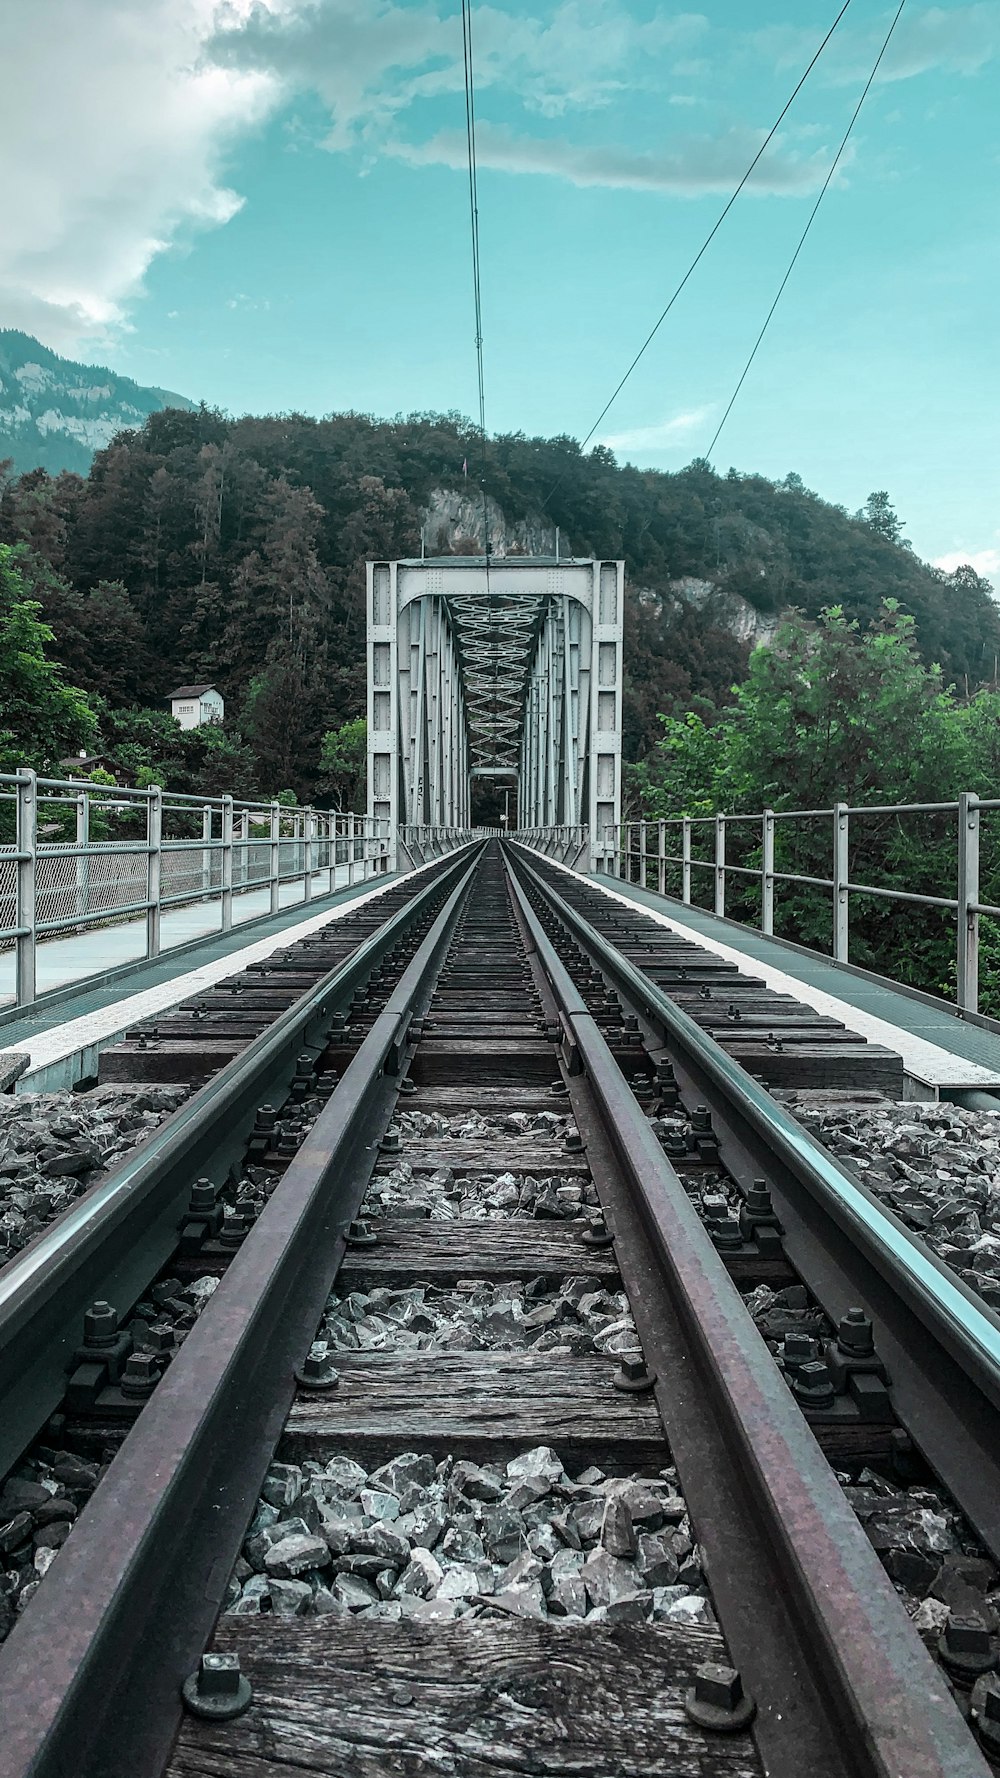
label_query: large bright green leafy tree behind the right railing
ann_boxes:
[633,599,1000,1010]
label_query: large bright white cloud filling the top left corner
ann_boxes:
[0,0,274,348]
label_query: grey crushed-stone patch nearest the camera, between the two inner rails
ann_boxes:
[226,1446,715,1625]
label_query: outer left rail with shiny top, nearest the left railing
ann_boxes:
[0,850,468,1474]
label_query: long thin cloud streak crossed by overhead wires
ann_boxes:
[384,124,829,197]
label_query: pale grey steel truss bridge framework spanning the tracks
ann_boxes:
[368,557,625,869]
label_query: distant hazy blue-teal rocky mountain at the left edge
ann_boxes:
[0,327,196,475]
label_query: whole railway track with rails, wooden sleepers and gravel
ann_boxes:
[0,845,1000,1778]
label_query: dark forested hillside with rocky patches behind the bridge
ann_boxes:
[0,407,1000,795]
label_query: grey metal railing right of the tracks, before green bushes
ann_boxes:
[616,791,1000,1012]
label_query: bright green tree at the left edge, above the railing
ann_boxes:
[0,544,96,773]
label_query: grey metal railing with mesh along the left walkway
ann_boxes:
[0,770,393,1006]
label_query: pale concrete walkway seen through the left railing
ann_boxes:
[0,864,364,1009]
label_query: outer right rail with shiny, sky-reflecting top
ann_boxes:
[518,855,1000,1558]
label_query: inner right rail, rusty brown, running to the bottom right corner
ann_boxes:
[501,855,988,1778]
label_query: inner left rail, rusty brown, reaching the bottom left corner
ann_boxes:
[0,842,479,1778]
